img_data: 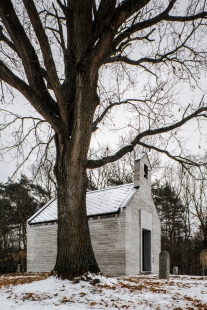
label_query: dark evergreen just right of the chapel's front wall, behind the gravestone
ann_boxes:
[152,183,189,273]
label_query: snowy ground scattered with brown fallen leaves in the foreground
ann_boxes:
[0,274,207,310]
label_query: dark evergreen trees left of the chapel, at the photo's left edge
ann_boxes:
[0,175,50,273]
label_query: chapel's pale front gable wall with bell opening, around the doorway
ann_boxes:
[126,156,161,275]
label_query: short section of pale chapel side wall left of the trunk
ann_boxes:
[27,224,57,272]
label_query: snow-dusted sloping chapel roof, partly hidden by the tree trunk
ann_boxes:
[28,183,137,224]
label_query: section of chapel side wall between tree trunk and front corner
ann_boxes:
[89,212,126,276]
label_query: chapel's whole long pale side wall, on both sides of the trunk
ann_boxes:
[27,213,126,275]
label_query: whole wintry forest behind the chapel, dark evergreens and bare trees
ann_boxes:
[0,150,207,275]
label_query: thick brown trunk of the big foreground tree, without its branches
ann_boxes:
[54,75,99,279]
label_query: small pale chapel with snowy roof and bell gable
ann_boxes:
[27,154,160,275]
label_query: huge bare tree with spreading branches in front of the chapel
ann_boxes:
[0,0,207,278]
